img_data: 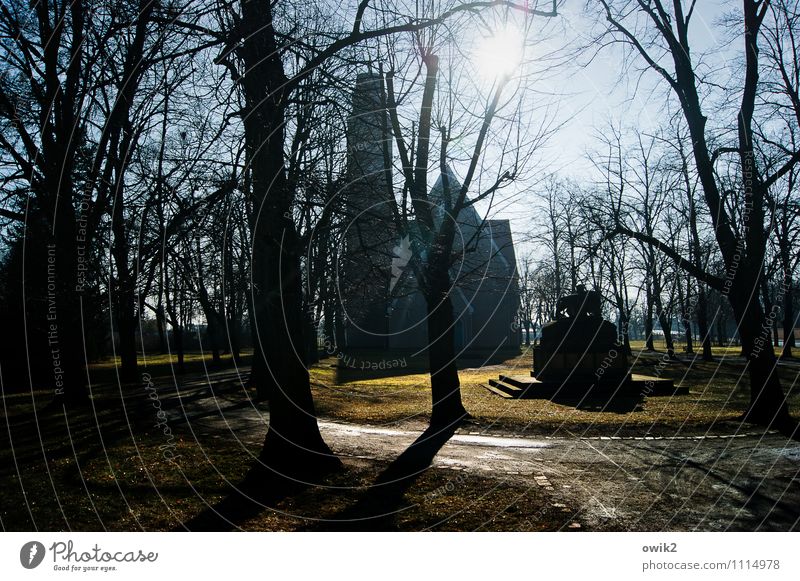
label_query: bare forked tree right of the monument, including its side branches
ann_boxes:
[600,0,800,429]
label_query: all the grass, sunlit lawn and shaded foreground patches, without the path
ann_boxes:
[0,345,800,530]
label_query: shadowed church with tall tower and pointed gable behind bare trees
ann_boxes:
[338,73,520,356]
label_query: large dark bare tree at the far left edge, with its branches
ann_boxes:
[0,0,104,401]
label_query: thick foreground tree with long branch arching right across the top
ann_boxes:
[217,0,555,475]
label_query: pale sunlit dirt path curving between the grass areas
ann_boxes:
[158,376,800,531]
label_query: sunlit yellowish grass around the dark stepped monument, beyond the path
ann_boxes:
[311,342,800,435]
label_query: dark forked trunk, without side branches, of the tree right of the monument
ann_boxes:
[609,0,790,428]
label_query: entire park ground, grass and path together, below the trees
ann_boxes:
[0,349,800,531]
